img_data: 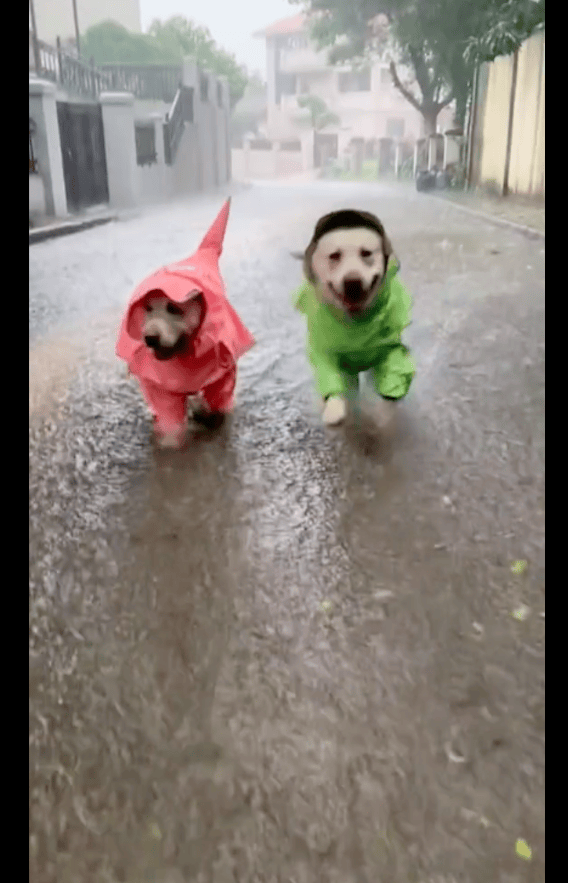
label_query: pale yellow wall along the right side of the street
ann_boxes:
[472,32,545,196]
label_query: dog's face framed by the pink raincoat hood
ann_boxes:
[142,291,205,361]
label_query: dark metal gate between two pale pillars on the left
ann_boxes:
[57,102,108,211]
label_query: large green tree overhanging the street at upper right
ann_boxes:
[290,0,544,134]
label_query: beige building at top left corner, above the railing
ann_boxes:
[30,0,142,46]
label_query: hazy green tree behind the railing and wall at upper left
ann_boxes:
[81,16,248,107]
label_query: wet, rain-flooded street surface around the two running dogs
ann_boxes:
[30,182,545,883]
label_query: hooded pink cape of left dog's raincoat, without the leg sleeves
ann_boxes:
[116,199,254,389]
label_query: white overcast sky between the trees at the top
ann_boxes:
[140,0,301,78]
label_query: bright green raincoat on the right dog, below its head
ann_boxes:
[294,259,415,399]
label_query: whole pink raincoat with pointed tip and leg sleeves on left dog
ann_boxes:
[116,199,255,444]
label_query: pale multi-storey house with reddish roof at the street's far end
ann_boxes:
[253,14,452,166]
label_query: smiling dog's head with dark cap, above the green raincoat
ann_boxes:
[304,210,392,316]
